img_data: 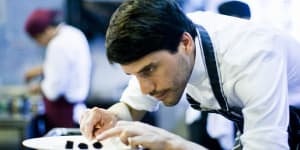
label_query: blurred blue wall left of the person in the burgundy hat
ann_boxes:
[0,0,64,86]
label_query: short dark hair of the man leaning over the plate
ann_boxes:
[105,0,196,64]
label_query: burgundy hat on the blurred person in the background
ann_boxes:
[25,9,55,37]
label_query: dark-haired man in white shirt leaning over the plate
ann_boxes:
[80,0,300,150]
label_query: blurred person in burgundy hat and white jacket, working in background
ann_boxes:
[25,9,91,135]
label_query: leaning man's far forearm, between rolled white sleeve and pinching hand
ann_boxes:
[108,102,146,121]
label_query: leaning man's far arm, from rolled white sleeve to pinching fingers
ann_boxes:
[80,78,158,139]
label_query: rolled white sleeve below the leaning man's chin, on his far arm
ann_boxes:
[120,77,159,111]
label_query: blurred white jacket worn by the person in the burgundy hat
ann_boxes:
[41,25,91,122]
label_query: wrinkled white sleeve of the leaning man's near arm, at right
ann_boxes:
[234,36,289,150]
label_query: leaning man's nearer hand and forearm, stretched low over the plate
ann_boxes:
[96,121,209,150]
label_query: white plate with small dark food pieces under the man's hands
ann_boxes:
[22,136,130,150]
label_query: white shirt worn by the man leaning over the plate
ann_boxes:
[121,12,300,150]
